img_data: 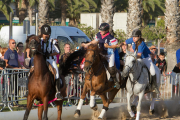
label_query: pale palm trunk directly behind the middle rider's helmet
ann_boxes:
[101,0,115,35]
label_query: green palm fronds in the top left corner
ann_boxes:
[0,0,13,20]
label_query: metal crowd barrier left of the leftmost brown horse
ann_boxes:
[0,68,29,111]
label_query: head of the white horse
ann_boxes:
[122,49,137,77]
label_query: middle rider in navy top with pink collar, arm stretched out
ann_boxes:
[82,23,120,89]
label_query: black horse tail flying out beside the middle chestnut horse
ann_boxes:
[59,49,86,76]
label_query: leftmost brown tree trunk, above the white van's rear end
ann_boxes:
[18,0,27,23]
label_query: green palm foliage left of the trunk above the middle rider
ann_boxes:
[67,0,97,26]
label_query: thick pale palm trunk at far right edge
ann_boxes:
[165,0,180,72]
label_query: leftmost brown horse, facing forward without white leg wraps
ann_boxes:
[24,36,66,120]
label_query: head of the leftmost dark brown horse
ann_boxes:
[26,35,42,54]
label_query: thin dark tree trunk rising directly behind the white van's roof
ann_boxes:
[60,0,67,26]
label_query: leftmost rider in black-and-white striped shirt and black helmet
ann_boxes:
[41,25,63,100]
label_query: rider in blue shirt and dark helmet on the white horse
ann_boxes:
[123,29,160,94]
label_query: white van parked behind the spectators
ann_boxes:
[0,26,91,43]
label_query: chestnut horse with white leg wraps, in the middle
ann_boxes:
[74,44,122,119]
